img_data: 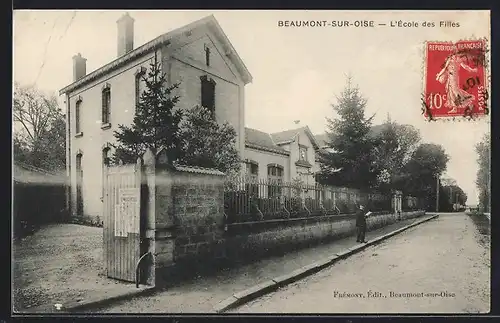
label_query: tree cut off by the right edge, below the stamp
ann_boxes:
[475,133,491,212]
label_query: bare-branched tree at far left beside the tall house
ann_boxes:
[12,83,66,170]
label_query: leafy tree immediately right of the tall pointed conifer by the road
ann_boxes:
[374,116,421,189]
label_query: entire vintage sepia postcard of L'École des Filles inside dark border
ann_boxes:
[12,10,493,315]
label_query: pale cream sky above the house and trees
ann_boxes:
[13,10,490,204]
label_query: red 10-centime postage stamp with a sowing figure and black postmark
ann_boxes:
[422,40,489,120]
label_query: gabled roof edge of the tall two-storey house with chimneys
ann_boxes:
[59,15,253,95]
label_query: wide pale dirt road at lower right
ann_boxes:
[232,213,490,313]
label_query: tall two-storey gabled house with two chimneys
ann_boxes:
[60,14,252,217]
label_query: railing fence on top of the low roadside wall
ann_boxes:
[224,178,392,223]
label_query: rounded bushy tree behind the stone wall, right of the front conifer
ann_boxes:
[179,106,240,174]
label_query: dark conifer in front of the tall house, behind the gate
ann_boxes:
[113,62,182,163]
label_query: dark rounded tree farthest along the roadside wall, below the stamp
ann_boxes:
[401,143,449,199]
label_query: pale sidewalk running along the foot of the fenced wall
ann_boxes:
[93,214,434,313]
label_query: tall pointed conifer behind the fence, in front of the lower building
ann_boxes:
[318,77,378,189]
